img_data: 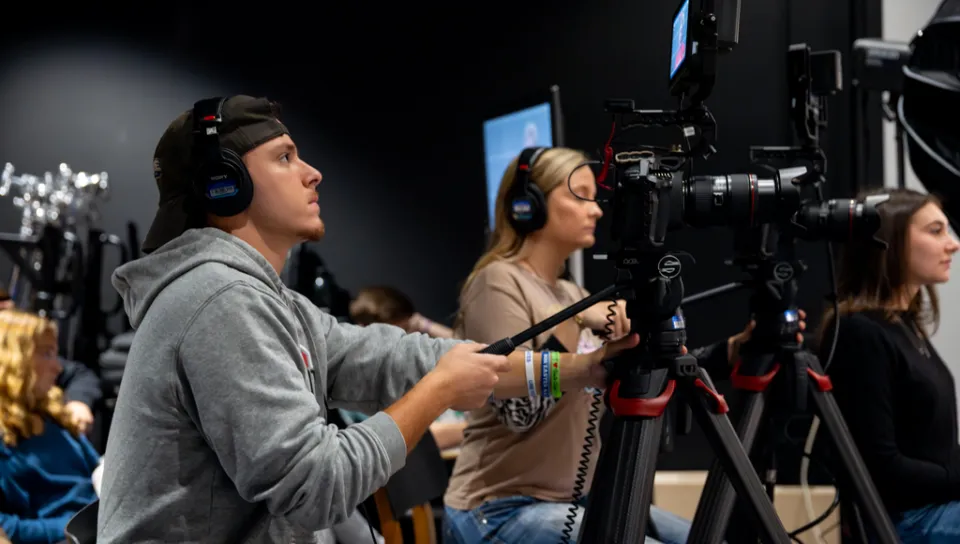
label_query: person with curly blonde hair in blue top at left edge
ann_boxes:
[0,310,100,544]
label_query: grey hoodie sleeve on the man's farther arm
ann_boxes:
[314,309,462,413]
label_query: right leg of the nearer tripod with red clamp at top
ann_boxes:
[680,369,790,543]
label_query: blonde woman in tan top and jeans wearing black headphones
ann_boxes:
[444,148,764,544]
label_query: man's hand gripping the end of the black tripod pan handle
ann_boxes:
[430,344,510,412]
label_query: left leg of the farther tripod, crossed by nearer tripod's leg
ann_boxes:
[690,356,779,544]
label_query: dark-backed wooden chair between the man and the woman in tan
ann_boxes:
[373,432,449,544]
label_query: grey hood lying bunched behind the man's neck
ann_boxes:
[111,228,285,329]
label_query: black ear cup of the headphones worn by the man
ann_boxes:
[198,149,253,217]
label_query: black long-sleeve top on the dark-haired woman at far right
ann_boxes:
[822,312,960,514]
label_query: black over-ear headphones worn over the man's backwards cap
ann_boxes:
[193,97,253,217]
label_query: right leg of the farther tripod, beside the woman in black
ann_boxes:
[806,353,900,544]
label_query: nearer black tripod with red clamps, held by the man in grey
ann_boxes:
[578,251,789,544]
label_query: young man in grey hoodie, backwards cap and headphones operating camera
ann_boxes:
[98,96,637,544]
